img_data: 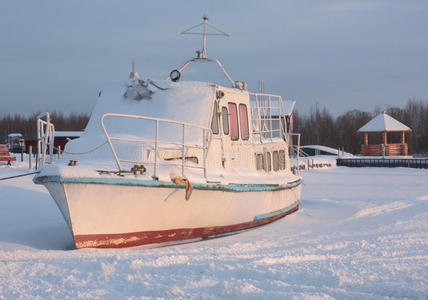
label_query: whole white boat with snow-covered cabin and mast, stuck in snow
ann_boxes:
[33,15,302,248]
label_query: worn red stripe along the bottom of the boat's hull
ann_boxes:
[74,205,299,248]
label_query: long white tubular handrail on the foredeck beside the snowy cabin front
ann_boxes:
[100,113,212,178]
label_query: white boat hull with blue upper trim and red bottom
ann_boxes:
[36,178,301,248]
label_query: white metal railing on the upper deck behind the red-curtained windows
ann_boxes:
[249,93,288,142]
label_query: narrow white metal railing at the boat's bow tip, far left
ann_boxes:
[36,112,55,167]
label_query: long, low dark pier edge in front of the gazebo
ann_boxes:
[336,158,428,169]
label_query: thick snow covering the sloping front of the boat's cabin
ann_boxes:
[67,80,215,152]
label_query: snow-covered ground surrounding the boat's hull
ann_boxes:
[0,163,428,299]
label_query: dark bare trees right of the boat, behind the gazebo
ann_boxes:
[294,99,428,154]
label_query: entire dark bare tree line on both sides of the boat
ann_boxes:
[0,99,428,154]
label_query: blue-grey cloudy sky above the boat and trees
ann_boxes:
[0,0,428,116]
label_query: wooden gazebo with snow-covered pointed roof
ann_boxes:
[358,112,412,156]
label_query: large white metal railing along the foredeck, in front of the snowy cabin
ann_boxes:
[100,113,212,178]
